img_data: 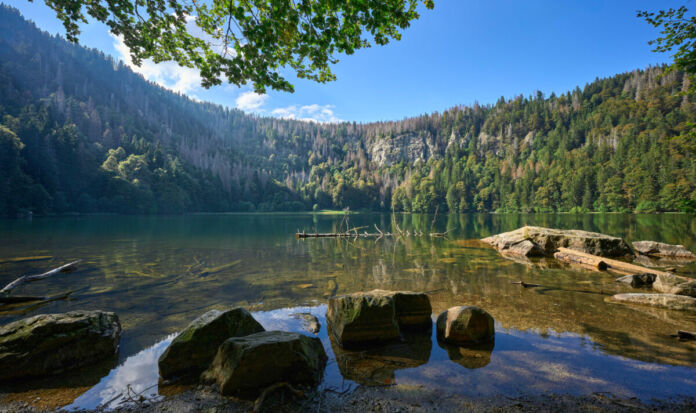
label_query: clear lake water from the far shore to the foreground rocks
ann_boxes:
[0,214,696,407]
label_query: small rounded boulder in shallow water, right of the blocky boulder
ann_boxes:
[437,306,495,345]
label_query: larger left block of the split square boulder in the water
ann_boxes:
[326,290,399,348]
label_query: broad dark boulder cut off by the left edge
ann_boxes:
[0,311,121,380]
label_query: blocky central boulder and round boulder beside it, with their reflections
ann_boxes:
[326,290,495,385]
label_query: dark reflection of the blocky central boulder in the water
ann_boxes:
[329,330,433,386]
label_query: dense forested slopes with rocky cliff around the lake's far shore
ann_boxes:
[0,6,696,216]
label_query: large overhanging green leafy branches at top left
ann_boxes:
[38,0,434,93]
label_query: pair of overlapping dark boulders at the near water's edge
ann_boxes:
[158,307,327,397]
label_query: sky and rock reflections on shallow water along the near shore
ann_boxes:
[66,305,696,410]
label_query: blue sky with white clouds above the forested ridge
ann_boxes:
[10,0,690,122]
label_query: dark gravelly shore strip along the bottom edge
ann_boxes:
[0,385,696,413]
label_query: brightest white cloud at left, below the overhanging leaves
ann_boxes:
[111,34,201,94]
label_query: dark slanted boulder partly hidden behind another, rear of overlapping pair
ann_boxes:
[158,307,264,379]
